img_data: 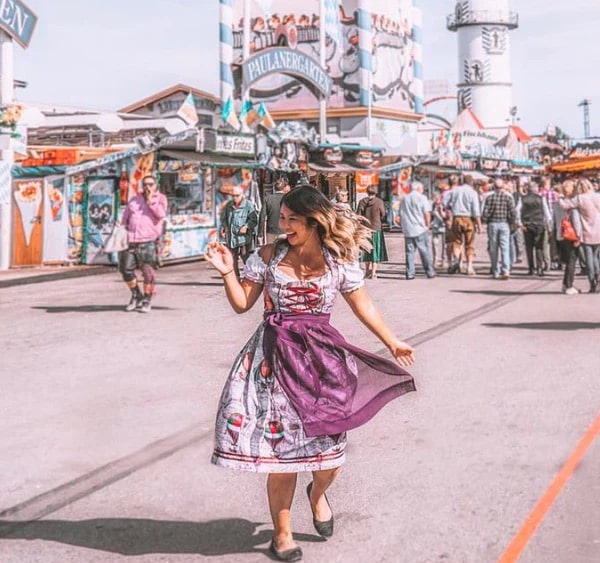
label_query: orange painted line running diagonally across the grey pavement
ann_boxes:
[498,413,600,563]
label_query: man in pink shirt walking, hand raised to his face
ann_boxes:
[119,176,167,313]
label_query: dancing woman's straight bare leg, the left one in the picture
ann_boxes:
[267,473,298,551]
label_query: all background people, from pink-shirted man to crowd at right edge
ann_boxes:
[119,174,600,313]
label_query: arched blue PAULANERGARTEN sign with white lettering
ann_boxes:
[240,48,331,97]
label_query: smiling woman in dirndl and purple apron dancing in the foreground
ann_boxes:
[206,185,415,561]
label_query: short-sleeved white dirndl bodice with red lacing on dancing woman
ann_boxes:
[242,242,364,315]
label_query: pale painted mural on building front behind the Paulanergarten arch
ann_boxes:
[233,0,415,112]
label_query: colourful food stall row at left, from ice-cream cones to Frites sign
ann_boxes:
[12,129,258,266]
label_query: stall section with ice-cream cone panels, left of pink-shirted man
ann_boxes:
[12,148,148,266]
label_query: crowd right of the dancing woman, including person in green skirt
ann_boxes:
[328,174,600,295]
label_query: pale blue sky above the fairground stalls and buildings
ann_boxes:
[10,0,600,137]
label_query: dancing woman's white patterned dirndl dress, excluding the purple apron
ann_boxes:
[211,242,414,473]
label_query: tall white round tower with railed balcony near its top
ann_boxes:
[447,0,519,128]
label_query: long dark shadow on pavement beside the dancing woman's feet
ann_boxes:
[0,518,322,556]
